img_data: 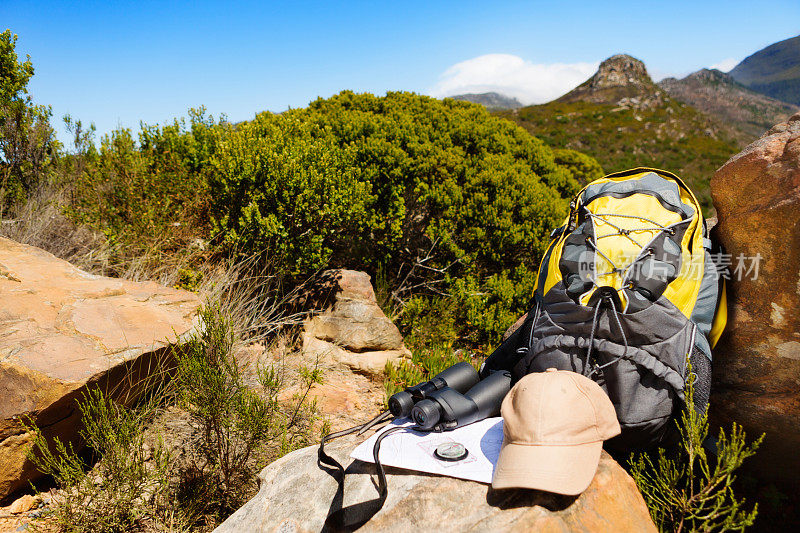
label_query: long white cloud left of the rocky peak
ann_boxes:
[429,54,599,105]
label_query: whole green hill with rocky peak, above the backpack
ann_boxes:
[498,55,746,213]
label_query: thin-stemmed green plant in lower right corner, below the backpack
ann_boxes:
[631,374,764,533]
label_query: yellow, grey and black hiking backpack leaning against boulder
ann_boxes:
[482,168,727,451]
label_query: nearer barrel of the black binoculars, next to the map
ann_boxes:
[411,371,511,430]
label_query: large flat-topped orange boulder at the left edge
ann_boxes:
[0,238,199,500]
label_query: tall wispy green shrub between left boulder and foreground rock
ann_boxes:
[178,304,321,518]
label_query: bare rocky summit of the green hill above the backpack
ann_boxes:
[557,54,664,107]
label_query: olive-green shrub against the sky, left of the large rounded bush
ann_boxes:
[69,108,217,253]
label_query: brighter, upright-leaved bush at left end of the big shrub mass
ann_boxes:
[211,112,378,276]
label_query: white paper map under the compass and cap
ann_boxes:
[350,417,503,483]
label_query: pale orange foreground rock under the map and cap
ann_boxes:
[216,439,656,533]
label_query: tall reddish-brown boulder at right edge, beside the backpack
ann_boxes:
[711,113,800,483]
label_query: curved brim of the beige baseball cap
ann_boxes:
[492,441,603,496]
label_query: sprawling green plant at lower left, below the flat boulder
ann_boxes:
[28,389,173,532]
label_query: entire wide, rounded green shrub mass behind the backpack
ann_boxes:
[209,91,578,342]
